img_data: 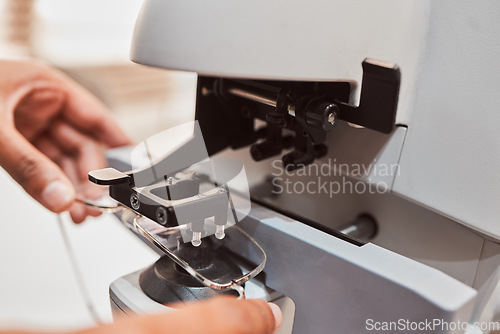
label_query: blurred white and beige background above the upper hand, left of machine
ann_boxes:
[0,0,196,140]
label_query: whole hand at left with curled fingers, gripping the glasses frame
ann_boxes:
[0,60,130,223]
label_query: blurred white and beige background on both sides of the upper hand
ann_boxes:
[0,0,196,330]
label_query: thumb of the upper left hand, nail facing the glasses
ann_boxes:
[0,127,75,213]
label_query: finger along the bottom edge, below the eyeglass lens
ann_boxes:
[82,297,281,334]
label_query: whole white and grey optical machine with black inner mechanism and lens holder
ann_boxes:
[90,0,500,333]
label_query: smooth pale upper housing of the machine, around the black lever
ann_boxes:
[131,0,500,239]
